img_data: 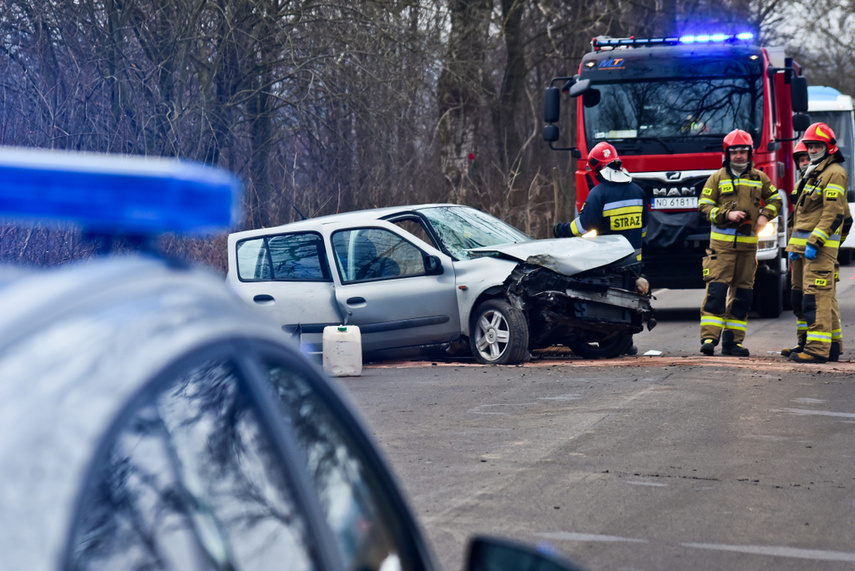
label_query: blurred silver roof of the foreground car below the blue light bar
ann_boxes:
[0,256,297,569]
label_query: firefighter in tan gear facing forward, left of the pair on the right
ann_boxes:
[698,129,783,357]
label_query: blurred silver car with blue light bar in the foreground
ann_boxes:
[0,149,572,571]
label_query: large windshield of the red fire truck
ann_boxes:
[582,48,764,155]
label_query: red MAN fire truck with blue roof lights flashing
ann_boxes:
[543,34,810,317]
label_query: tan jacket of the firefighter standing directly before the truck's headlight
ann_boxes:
[698,164,783,251]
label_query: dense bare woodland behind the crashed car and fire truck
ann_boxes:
[0,0,808,269]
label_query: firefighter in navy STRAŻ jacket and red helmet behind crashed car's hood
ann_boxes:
[552,141,647,355]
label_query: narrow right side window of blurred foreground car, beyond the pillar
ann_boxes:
[268,362,423,570]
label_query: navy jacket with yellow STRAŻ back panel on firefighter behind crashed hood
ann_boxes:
[555,180,647,253]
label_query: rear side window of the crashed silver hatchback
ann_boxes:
[237,232,332,281]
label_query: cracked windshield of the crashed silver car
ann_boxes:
[419,206,531,260]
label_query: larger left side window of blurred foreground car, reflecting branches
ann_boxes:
[68,362,317,570]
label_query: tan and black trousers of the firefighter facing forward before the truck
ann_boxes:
[701,248,757,345]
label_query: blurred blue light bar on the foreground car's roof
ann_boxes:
[0,147,241,236]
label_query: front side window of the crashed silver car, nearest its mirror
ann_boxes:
[332,228,426,283]
